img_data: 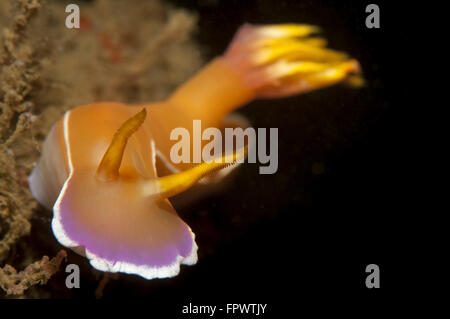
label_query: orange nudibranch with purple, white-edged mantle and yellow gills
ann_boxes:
[29,24,362,279]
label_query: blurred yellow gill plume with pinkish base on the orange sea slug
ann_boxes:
[225,24,364,97]
